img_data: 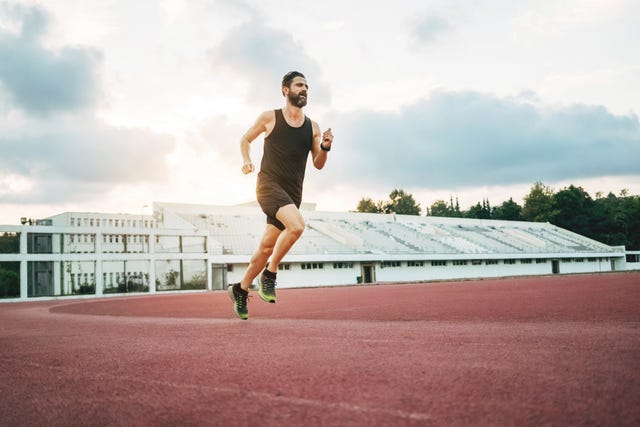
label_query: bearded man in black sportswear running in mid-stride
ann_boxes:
[228,71,333,320]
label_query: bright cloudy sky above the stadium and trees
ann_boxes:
[0,0,640,224]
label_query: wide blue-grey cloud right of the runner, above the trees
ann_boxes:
[329,91,640,188]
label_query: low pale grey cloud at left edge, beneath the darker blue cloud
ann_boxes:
[0,116,173,202]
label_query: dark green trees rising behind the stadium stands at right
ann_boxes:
[356,182,640,250]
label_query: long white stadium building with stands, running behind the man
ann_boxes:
[0,203,640,300]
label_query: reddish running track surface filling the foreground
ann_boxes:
[0,272,640,426]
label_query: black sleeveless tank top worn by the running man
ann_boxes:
[260,109,313,195]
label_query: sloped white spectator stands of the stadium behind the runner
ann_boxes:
[154,203,617,258]
